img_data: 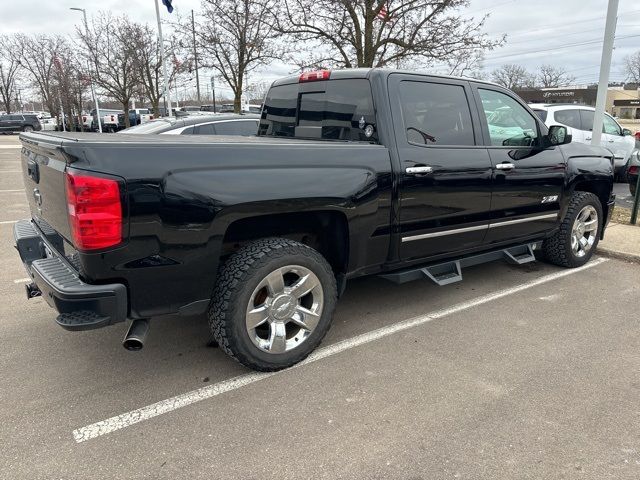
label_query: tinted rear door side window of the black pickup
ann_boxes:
[400,81,475,145]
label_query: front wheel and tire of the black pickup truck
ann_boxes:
[542,192,603,268]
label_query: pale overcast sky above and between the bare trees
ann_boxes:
[0,0,640,97]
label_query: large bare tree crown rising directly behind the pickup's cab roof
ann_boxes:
[276,0,503,68]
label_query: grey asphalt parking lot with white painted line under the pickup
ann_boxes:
[0,136,640,480]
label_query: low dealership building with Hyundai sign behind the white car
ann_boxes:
[514,84,640,119]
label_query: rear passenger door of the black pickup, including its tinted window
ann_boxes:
[389,74,491,260]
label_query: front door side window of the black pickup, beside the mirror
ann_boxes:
[478,88,538,147]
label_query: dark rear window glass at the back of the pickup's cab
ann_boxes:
[258,79,377,142]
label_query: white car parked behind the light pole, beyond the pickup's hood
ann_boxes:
[529,103,636,178]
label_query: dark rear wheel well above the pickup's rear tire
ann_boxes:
[222,211,349,273]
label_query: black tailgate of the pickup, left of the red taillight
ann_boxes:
[20,133,71,246]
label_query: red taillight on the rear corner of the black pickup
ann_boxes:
[65,172,122,250]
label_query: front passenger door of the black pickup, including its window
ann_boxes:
[474,85,566,244]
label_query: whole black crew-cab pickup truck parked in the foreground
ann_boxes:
[14,69,614,370]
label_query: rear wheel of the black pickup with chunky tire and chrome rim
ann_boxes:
[209,238,337,371]
